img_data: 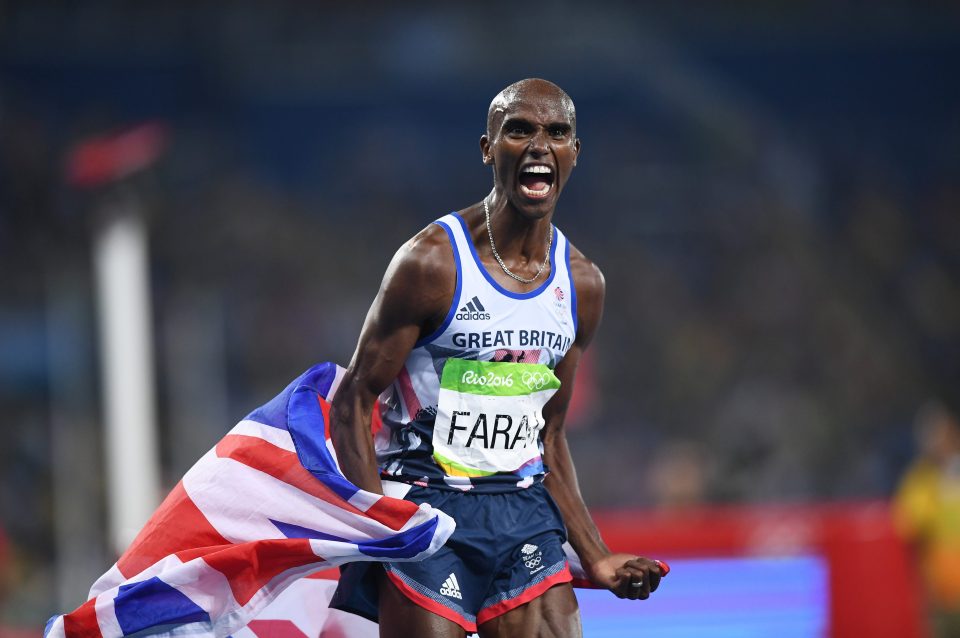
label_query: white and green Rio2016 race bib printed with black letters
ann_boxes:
[433,358,560,477]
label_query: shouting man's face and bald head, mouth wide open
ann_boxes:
[480,81,580,219]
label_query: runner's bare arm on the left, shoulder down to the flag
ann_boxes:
[330,225,456,494]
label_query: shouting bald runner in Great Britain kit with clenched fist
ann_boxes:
[331,79,661,637]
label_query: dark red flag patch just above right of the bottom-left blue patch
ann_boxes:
[203,538,323,606]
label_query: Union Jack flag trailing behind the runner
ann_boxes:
[44,363,454,638]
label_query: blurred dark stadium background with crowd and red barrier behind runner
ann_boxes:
[0,0,960,636]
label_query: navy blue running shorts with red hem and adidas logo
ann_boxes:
[330,483,572,632]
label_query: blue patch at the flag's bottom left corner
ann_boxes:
[113,576,210,636]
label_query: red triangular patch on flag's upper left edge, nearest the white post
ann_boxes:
[117,481,230,578]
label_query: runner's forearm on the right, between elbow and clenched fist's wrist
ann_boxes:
[544,435,610,569]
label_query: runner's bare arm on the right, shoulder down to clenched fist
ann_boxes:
[543,251,660,598]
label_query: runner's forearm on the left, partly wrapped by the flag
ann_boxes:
[330,378,383,494]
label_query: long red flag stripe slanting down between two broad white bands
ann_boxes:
[217,434,364,516]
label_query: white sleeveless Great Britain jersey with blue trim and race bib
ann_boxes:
[375,213,577,493]
